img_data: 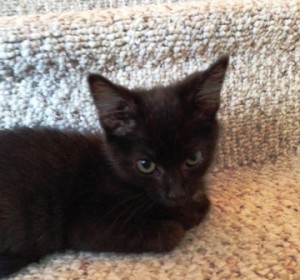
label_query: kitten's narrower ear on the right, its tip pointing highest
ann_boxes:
[194,55,229,116]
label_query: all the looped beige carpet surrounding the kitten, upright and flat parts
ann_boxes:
[0,0,300,280]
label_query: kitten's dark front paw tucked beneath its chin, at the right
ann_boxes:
[176,194,210,230]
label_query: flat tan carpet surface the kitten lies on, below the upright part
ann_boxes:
[7,154,300,280]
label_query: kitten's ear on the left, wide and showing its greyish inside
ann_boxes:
[88,74,136,136]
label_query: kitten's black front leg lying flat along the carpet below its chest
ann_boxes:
[69,219,185,253]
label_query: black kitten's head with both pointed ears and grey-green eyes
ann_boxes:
[88,56,229,206]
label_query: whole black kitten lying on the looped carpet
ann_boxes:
[0,56,228,277]
